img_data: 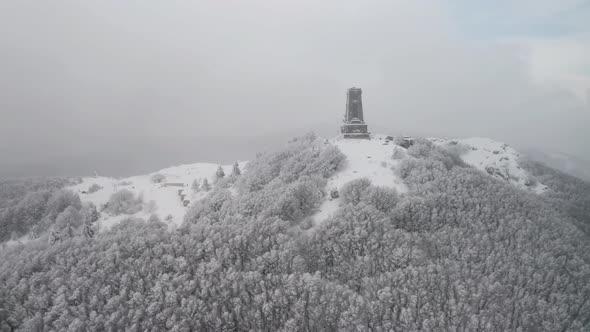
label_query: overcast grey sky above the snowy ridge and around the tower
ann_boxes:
[0,0,590,176]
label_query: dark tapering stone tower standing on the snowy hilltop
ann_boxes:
[340,87,370,138]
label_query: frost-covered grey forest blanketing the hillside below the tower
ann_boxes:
[0,134,590,331]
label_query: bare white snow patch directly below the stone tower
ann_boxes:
[312,135,408,225]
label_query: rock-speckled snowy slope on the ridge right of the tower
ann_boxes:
[430,137,548,194]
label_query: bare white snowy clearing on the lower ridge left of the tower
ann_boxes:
[69,162,246,229]
